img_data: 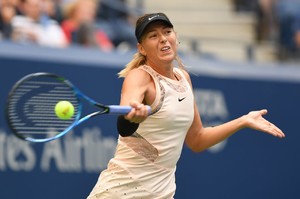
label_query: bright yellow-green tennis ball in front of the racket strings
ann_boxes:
[54,101,74,120]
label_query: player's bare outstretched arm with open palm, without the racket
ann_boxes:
[185,69,285,152]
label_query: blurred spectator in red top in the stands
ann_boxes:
[61,0,114,51]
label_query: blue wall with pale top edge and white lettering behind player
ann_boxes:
[0,43,300,199]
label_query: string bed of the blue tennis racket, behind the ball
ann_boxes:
[8,76,79,139]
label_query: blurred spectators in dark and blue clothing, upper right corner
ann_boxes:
[233,0,300,60]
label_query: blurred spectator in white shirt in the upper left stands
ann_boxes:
[12,0,66,47]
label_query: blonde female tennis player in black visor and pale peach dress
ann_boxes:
[88,13,285,199]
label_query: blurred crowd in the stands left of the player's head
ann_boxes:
[0,0,136,51]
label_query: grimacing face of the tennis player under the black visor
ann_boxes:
[138,21,177,65]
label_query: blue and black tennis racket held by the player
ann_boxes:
[6,72,151,142]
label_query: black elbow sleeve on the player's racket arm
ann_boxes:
[117,115,139,137]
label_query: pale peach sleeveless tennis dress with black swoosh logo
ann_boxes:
[88,65,194,199]
